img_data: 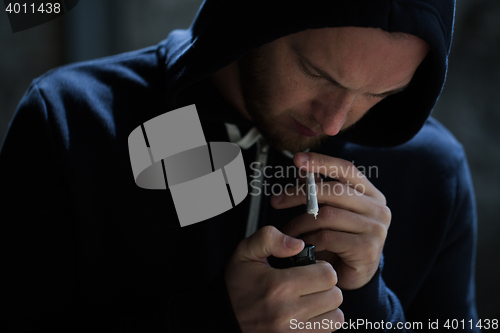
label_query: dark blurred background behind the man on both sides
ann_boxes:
[0,0,500,319]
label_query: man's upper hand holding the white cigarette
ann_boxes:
[271,153,391,290]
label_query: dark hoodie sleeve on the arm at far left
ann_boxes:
[0,84,76,332]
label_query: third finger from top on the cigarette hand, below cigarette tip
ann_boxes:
[282,206,376,237]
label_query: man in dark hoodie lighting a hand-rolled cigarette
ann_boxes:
[0,1,477,333]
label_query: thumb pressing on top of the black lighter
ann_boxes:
[237,226,304,263]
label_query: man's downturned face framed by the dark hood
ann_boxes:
[238,27,428,152]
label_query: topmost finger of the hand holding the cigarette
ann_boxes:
[293,153,386,205]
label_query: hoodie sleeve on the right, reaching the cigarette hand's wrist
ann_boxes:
[341,150,480,332]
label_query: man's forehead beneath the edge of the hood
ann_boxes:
[288,27,428,88]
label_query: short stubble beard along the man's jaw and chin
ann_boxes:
[238,46,327,153]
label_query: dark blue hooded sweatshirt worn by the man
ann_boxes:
[0,0,477,332]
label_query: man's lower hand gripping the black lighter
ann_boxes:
[225,226,344,333]
